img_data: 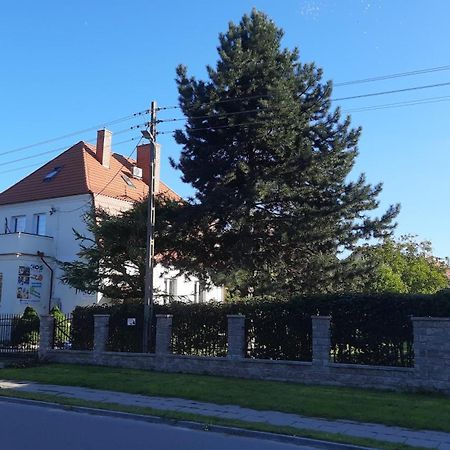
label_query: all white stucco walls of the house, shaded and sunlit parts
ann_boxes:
[0,194,223,314]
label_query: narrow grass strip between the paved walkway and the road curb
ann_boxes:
[0,389,420,450]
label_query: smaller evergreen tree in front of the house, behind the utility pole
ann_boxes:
[61,195,182,299]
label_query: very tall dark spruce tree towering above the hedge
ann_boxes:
[173,10,398,294]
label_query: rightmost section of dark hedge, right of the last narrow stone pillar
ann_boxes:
[321,293,450,366]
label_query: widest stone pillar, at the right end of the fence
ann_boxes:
[411,317,450,390]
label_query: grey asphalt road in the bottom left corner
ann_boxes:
[0,400,318,450]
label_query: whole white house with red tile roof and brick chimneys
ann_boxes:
[0,130,223,314]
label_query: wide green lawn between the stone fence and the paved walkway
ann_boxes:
[0,364,450,432]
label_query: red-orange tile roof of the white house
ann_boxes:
[0,141,181,205]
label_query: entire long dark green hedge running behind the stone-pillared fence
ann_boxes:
[72,292,450,366]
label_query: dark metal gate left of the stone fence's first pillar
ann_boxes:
[0,314,40,357]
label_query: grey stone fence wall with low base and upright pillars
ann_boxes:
[39,316,450,394]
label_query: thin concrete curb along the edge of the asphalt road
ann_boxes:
[0,396,373,450]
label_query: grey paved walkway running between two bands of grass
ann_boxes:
[0,380,450,450]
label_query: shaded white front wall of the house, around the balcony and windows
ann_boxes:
[0,195,96,314]
